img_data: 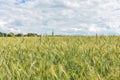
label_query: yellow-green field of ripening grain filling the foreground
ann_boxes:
[0,36,120,80]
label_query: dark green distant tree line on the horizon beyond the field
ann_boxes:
[0,32,54,37]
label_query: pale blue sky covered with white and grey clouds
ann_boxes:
[0,0,120,35]
